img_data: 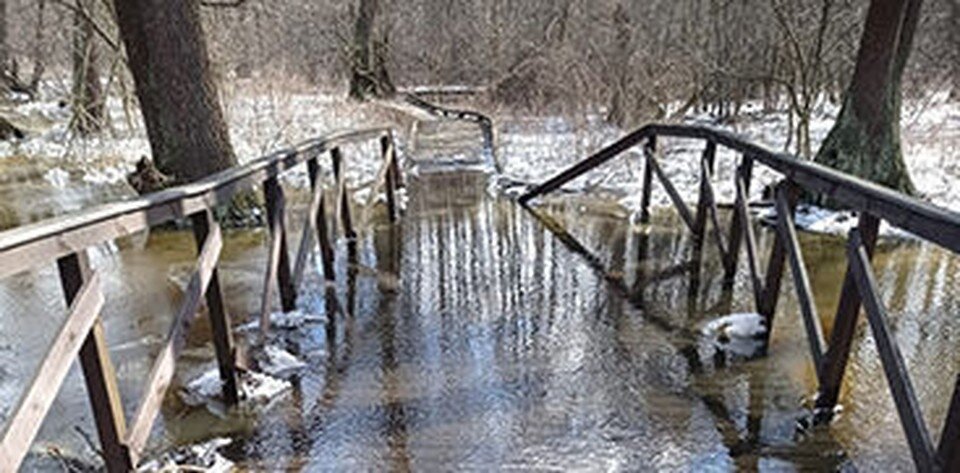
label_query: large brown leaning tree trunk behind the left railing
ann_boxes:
[114,0,237,182]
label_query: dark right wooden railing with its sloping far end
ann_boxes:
[520,125,960,472]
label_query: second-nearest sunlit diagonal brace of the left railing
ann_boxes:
[126,226,223,456]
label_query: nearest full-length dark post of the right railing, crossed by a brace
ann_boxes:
[816,213,880,412]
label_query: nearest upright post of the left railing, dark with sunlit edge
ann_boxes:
[57,250,135,473]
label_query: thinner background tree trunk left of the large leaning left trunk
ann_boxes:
[73,0,104,135]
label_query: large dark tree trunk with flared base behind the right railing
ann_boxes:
[815,0,922,194]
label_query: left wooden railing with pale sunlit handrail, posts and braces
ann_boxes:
[0,129,401,472]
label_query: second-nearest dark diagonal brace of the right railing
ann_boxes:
[777,185,826,379]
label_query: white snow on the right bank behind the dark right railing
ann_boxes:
[499,94,960,235]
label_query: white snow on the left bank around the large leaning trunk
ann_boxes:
[0,77,402,187]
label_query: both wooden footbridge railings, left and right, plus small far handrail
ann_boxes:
[0,99,960,471]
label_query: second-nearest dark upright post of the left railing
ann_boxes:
[190,210,240,405]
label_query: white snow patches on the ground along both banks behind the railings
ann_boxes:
[0,81,960,236]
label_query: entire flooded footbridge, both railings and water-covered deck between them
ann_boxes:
[0,97,960,471]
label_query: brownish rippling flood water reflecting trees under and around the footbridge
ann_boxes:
[0,166,960,471]
